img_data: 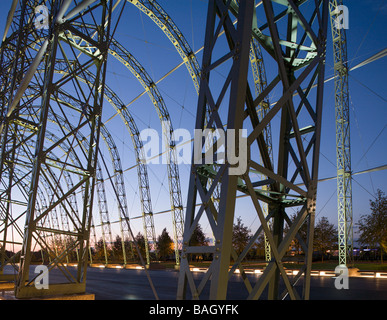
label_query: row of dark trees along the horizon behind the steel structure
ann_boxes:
[6,190,387,263]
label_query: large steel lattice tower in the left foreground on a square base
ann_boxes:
[0,0,112,298]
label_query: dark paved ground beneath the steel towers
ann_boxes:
[3,268,387,300]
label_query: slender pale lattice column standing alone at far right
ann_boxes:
[329,0,353,266]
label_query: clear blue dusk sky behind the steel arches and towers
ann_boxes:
[0,0,387,248]
